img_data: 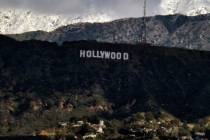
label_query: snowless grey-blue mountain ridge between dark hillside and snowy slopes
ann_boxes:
[9,14,210,50]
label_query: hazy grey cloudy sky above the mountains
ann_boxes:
[0,0,161,17]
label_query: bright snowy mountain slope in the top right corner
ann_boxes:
[160,0,210,16]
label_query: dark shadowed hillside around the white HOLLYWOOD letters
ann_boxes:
[0,36,210,139]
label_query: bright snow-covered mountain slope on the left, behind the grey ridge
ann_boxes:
[0,9,111,34]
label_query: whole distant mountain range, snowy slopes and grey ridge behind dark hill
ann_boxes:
[0,0,210,50]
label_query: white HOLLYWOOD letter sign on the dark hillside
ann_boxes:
[80,50,130,61]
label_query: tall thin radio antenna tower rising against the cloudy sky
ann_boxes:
[142,0,147,44]
